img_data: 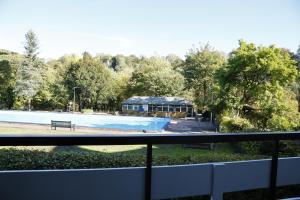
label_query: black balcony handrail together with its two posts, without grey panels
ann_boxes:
[0,131,300,200]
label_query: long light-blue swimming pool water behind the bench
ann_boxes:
[0,111,170,131]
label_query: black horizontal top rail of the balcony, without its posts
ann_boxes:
[0,132,300,146]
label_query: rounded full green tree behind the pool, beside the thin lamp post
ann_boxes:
[66,52,113,109]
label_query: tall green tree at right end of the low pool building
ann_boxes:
[183,44,225,110]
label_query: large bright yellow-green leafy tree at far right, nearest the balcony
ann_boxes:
[218,41,299,130]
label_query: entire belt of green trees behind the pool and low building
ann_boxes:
[0,31,300,132]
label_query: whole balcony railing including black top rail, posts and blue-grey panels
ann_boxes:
[0,132,300,200]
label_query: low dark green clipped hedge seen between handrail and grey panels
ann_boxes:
[0,148,261,170]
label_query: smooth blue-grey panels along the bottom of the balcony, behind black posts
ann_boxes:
[0,157,300,200]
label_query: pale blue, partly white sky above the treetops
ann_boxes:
[0,0,300,58]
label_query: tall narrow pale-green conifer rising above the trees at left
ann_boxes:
[15,30,43,110]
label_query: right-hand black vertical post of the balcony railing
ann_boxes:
[270,140,279,200]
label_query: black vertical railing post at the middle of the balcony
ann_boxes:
[145,144,152,200]
